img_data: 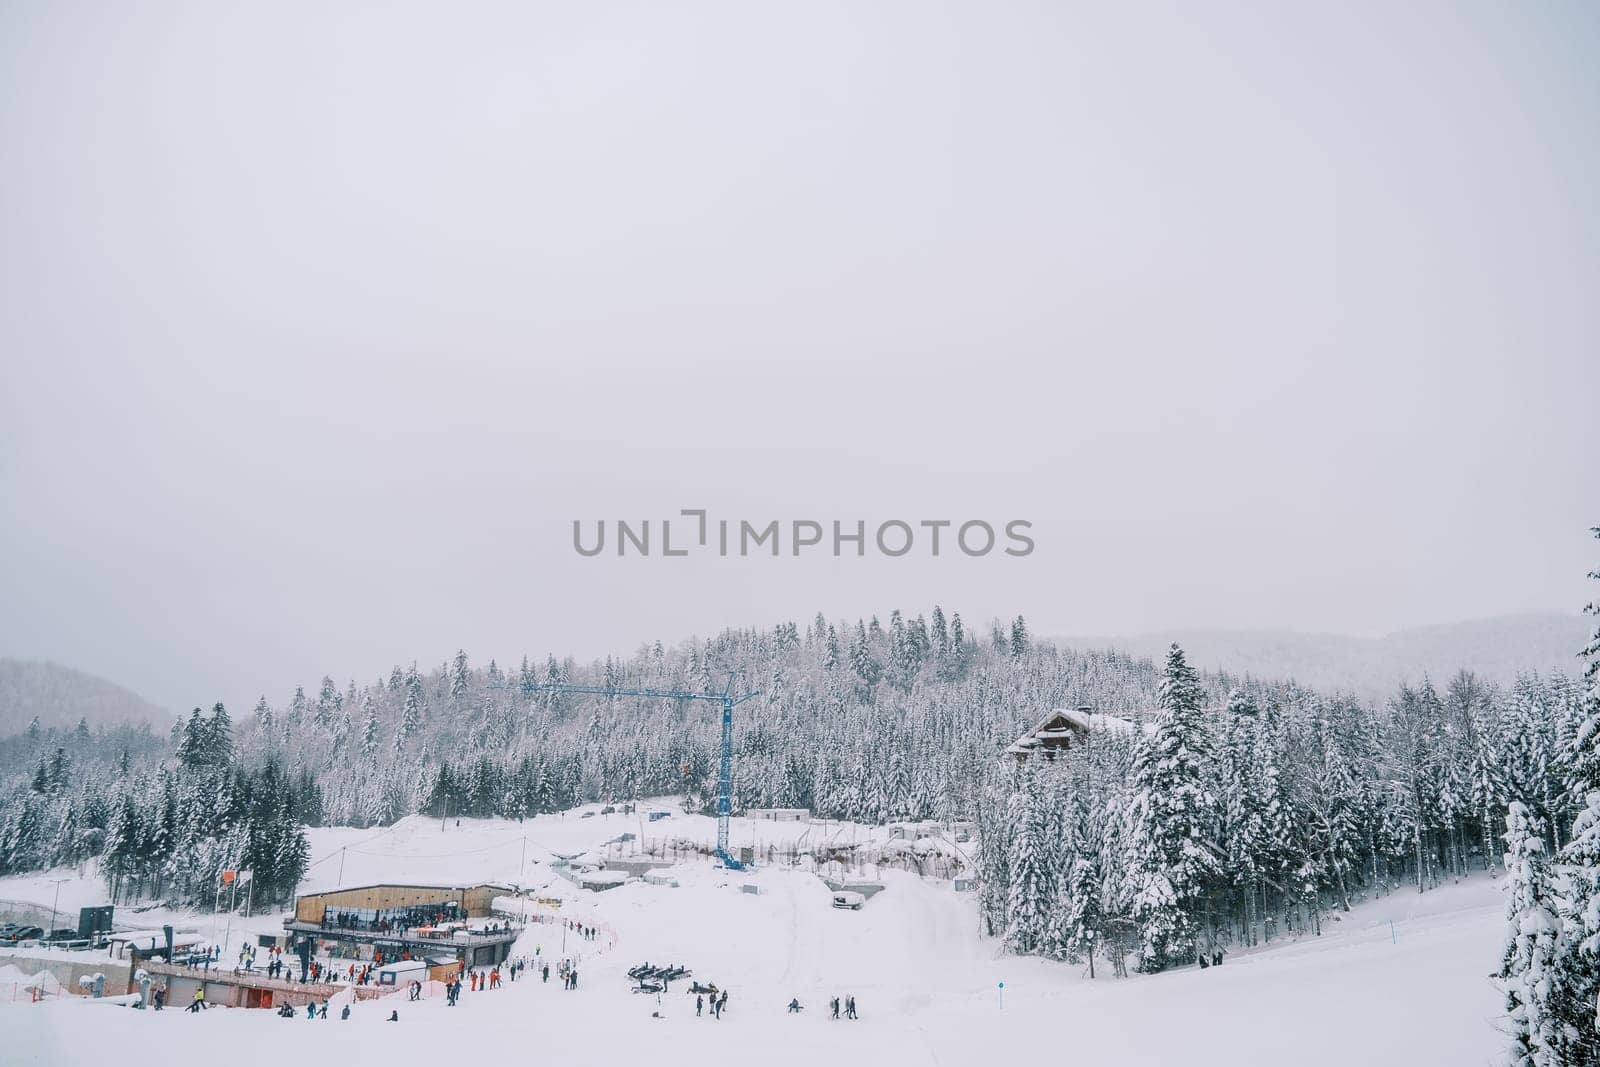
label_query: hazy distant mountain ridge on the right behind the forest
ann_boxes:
[1053,614,1590,701]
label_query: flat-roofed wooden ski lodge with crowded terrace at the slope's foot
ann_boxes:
[283,883,522,968]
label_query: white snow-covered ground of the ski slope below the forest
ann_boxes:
[0,813,1501,1067]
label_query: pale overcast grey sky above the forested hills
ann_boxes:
[0,0,1600,707]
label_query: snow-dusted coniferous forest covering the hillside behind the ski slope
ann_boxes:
[0,534,1600,1062]
